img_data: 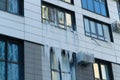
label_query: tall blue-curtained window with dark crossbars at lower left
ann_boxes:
[0,37,24,80]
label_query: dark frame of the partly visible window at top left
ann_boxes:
[0,0,24,16]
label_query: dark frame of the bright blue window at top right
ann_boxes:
[81,0,110,18]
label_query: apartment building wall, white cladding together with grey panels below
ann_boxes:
[0,0,120,80]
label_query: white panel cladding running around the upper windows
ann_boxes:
[0,0,120,63]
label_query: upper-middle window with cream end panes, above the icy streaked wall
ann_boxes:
[42,1,76,30]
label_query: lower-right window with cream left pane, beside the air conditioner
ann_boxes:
[93,60,114,80]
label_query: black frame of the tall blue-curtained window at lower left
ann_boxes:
[0,35,25,80]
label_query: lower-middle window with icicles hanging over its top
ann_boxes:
[50,49,75,80]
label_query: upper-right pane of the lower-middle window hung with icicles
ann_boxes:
[61,53,70,72]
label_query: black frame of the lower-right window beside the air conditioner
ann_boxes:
[93,58,114,80]
